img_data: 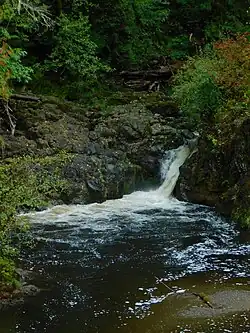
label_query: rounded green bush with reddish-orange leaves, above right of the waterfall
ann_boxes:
[173,33,250,125]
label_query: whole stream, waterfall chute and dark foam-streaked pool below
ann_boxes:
[0,146,250,333]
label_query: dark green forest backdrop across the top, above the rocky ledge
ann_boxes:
[0,0,249,98]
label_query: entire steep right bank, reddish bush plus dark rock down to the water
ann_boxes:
[174,32,250,228]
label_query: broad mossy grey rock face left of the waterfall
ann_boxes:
[0,93,192,204]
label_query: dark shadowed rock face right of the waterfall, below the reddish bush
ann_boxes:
[176,117,250,226]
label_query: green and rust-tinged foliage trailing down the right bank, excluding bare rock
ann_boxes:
[173,33,250,228]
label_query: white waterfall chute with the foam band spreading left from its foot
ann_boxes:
[24,141,193,223]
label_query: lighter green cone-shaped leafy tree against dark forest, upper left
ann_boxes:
[46,15,109,82]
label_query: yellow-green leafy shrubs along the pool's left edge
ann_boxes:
[0,153,69,291]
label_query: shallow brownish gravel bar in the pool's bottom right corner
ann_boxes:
[141,272,250,332]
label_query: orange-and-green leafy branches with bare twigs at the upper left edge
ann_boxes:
[0,0,53,135]
